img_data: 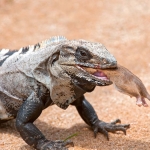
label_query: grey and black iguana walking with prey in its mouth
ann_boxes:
[0,36,129,150]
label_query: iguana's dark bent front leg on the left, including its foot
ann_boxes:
[16,93,73,150]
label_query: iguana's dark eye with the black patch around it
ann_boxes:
[75,48,92,61]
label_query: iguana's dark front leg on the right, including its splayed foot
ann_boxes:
[72,96,130,140]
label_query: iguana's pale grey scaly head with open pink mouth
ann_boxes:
[52,40,117,86]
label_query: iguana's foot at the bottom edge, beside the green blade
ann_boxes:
[37,140,74,150]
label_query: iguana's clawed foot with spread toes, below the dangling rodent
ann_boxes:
[92,119,130,140]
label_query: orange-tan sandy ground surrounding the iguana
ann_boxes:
[0,0,150,150]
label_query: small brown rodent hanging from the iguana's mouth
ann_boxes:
[101,65,150,107]
